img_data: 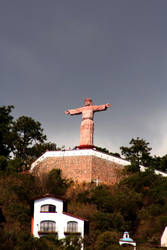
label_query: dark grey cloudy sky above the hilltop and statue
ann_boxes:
[0,0,167,155]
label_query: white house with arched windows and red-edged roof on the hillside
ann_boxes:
[31,194,87,242]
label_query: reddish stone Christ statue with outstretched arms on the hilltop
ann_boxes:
[65,98,111,148]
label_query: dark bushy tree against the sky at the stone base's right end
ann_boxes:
[120,137,151,167]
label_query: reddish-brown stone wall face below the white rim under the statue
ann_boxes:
[33,155,123,184]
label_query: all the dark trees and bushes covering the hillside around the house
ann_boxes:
[0,106,167,250]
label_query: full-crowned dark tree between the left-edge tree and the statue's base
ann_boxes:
[13,116,46,160]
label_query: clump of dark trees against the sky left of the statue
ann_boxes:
[0,106,58,168]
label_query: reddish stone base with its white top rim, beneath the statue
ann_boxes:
[31,149,129,185]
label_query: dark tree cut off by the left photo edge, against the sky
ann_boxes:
[0,106,14,157]
